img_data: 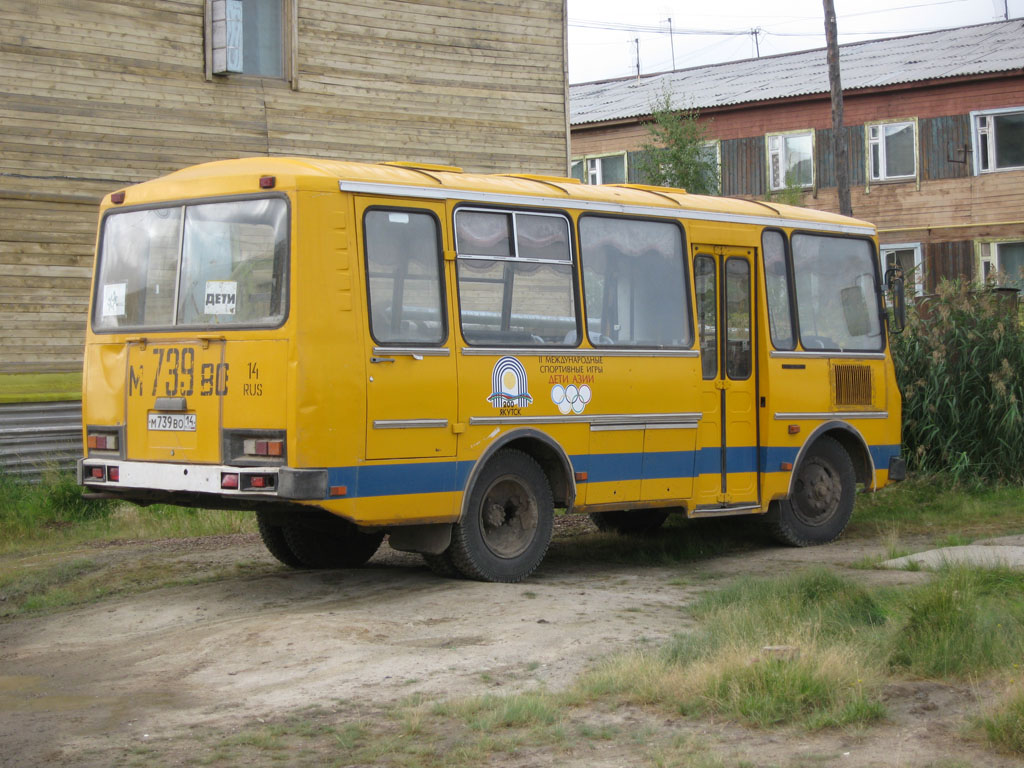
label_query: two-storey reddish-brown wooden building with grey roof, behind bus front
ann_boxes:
[570,19,1024,293]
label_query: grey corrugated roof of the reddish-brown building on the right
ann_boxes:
[569,19,1024,125]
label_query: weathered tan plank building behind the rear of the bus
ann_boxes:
[0,0,567,373]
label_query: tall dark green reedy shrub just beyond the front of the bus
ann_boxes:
[892,282,1024,483]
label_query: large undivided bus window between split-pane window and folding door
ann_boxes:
[580,216,693,347]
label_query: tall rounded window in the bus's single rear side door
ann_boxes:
[364,209,447,344]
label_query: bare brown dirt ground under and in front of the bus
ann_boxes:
[0,523,1019,768]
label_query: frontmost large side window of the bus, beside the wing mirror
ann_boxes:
[793,234,884,351]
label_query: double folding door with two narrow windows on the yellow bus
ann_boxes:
[692,245,760,514]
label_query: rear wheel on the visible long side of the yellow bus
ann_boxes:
[449,449,554,584]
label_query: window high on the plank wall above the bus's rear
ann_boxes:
[206,0,296,81]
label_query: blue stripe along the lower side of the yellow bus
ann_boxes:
[328,445,900,499]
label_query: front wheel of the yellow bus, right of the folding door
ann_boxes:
[765,437,857,547]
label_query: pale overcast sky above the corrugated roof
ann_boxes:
[568,0,1024,83]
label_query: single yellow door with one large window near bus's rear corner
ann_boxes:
[356,198,458,459]
